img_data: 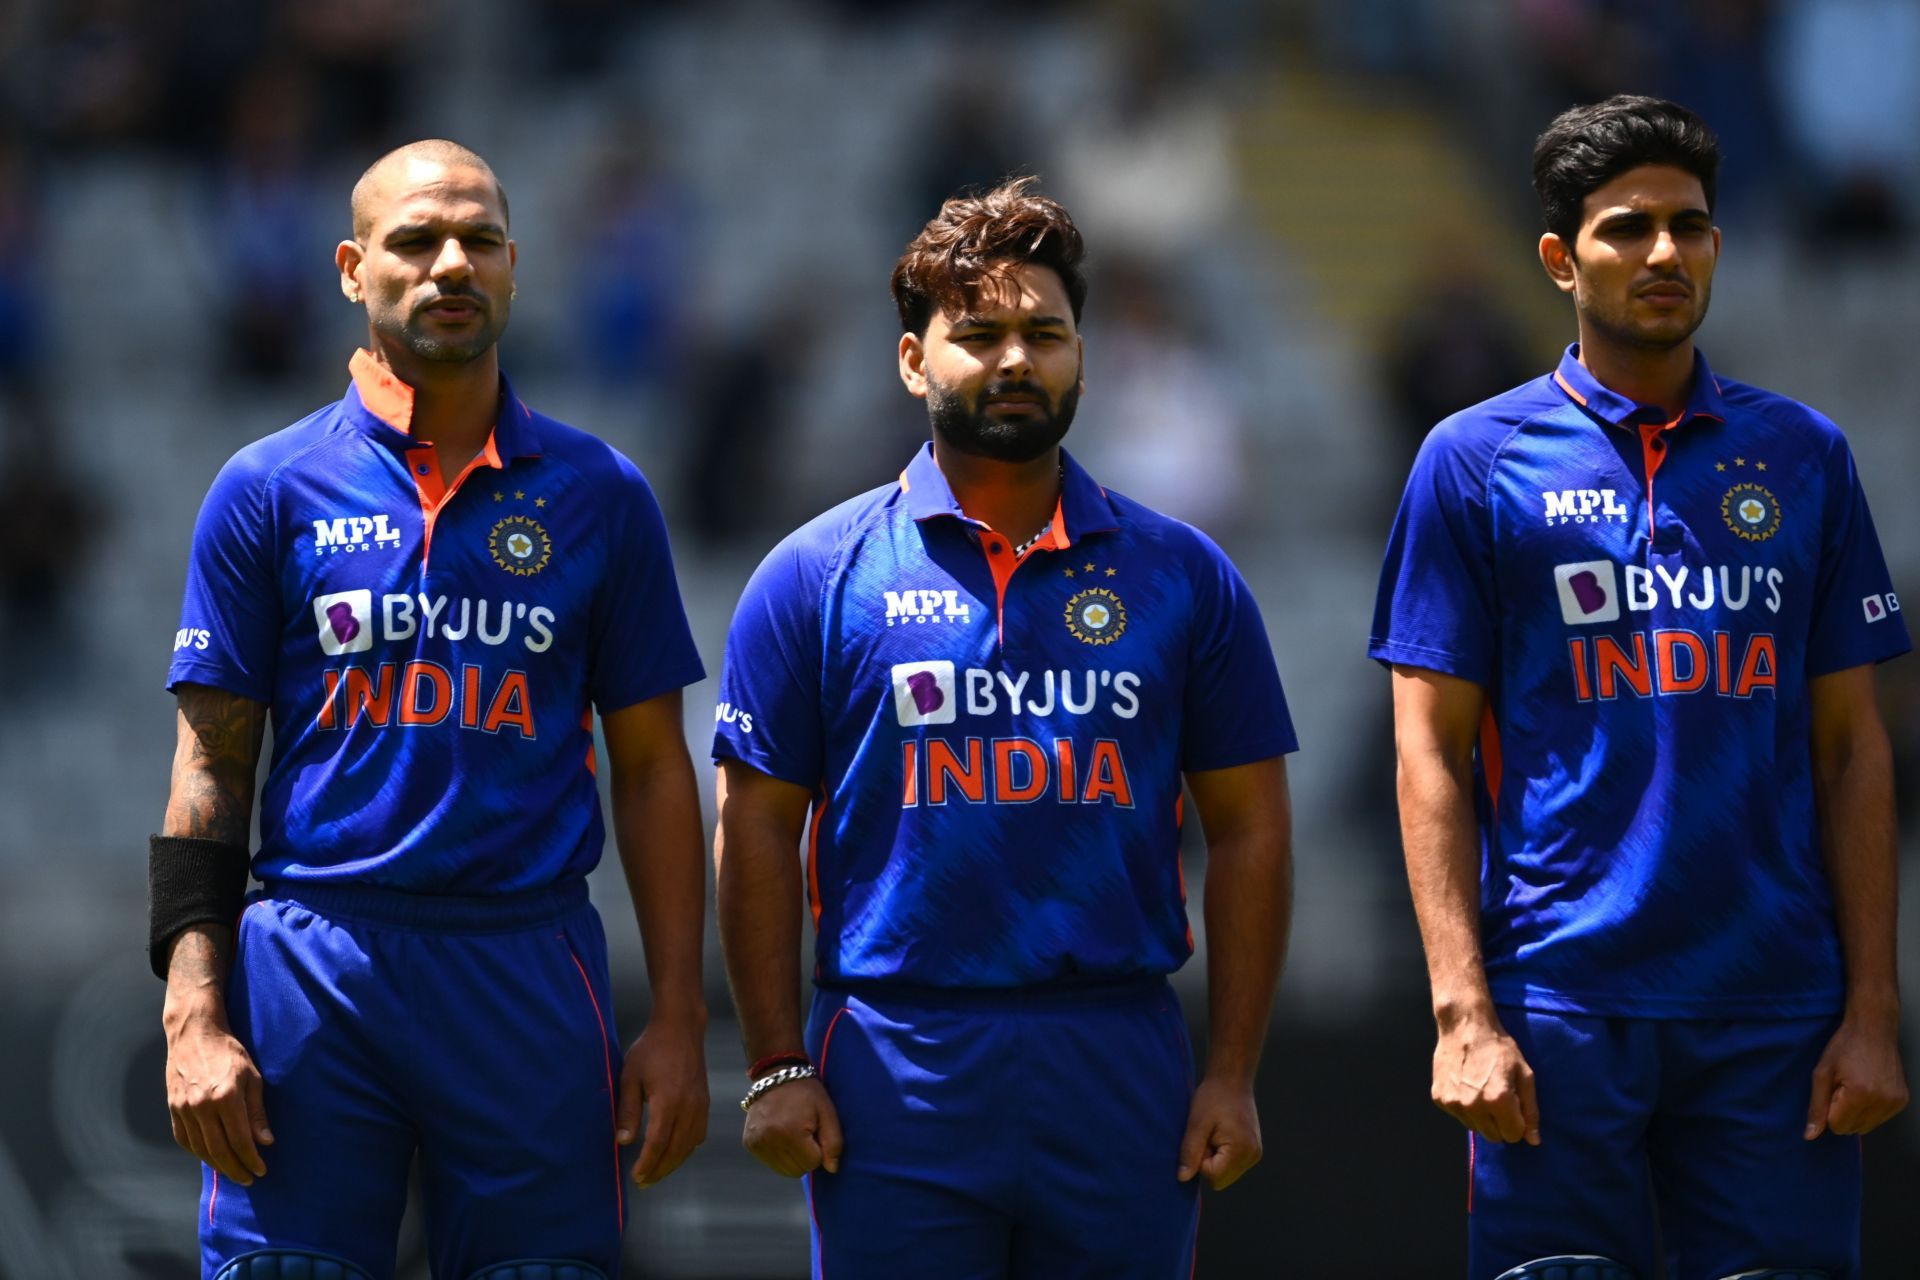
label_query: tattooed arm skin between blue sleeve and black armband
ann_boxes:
[161,685,267,846]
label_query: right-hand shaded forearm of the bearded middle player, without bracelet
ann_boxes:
[1206,825,1294,1084]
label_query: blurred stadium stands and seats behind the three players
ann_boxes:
[0,0,1920,1280]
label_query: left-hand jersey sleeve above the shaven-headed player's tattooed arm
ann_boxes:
[167,451,282,702]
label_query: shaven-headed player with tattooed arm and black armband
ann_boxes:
[152,140,707,1280]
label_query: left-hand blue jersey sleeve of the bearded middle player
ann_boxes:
[712,533,826,789]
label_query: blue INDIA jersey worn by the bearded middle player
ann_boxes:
[712,447,1294,988]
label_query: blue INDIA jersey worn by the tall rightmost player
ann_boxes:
[1369,347,1910,1017]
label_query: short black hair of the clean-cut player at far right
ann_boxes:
[1534,94,1720,246]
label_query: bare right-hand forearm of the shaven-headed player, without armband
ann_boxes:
[612,752,707,1025]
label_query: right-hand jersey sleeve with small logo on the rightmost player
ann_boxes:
[1807,432,1912,676]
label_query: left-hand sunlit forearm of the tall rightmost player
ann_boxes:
[1398,752,1494,1031]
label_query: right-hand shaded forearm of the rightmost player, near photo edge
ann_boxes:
[1814,723,1899,1025]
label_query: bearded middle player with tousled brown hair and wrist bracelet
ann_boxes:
[714,180,1294,1280]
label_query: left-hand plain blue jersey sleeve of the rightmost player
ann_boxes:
[1367,422,1496,685]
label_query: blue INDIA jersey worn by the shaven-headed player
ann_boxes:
[167,351,703,894]
